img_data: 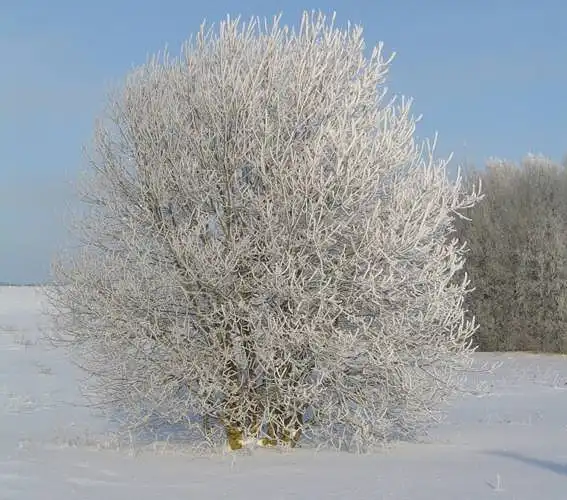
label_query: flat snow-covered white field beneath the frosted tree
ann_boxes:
[0,287,567,500]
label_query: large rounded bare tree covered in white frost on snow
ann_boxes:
[46,13,479,450]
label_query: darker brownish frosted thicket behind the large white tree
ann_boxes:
[459,156,567,352]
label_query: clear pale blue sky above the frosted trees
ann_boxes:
[0,0,567,283]
